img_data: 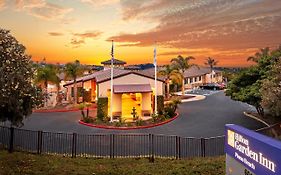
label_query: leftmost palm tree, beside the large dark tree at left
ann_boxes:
[35,65,59,106]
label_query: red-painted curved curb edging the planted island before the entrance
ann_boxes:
[78,112,179,130]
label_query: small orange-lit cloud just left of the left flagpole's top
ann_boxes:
[70,31,102,48]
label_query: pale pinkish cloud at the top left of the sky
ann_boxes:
[16,0,73,20]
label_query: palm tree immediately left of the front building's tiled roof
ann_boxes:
[64,60,83,104]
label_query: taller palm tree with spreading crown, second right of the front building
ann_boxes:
[171,55,196,95]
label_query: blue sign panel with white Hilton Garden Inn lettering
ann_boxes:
[225,125,281,175]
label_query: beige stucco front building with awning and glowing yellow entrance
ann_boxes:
[64,65,164,118]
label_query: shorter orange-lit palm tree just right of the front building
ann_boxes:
[158,65,181,98]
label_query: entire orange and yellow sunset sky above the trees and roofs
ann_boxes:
[0,0,281,66]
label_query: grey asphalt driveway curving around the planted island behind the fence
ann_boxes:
[3,91,263,137]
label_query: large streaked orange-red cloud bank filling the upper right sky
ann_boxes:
[108,0,281,50]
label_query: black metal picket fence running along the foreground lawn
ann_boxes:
[0,127,224,159]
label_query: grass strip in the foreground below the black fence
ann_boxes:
[0,150,225,175]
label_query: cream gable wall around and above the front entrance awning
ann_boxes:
[98,73,163,97]
